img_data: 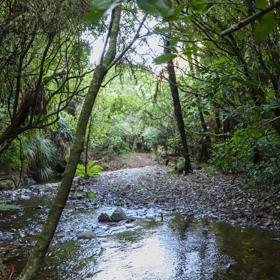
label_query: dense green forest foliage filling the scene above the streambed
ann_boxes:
[0,0,280,184]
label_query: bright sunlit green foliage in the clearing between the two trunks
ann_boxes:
[91,67,162,159]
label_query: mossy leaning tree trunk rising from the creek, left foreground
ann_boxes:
[18,6,121,280]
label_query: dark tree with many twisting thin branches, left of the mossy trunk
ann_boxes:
[0,0,89,155]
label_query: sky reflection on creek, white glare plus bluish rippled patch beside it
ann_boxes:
[88,215,230,280]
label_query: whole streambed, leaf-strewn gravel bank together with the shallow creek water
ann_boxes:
[0,166,280,280]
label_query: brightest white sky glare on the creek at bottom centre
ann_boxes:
[90,232,173,280]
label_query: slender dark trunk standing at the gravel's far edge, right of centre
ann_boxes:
[165,35,192,174]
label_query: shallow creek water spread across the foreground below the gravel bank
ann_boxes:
[0,198,280,280]
